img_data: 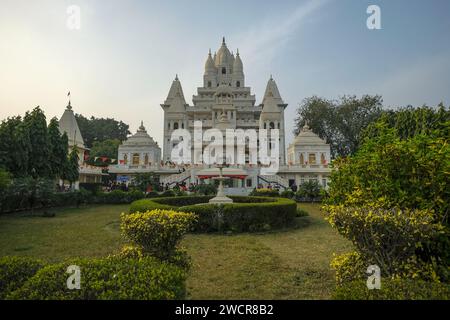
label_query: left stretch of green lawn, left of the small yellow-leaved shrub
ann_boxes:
[0,205,128,262]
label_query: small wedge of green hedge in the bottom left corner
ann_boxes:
[0,257,45,299]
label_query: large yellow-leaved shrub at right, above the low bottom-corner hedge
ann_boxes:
[324,205,443,278]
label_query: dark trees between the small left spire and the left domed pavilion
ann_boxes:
[75,114,130,148]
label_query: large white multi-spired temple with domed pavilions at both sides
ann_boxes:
[110,39,330,194]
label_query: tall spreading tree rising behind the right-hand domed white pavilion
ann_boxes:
[294,95,382,157]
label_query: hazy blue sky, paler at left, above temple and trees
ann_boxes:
[0,0,450,145]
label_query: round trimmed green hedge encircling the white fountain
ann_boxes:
[130,196,297,232]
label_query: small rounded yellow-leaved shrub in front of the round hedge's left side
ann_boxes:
[121,209,196,260]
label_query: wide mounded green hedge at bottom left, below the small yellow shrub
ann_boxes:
[7,257,186,300]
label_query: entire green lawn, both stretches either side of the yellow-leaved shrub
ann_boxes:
[0,204,351,299]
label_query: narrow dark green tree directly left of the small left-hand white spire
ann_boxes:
[48,118,69,178]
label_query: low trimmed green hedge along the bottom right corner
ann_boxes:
[333,278,450,300]
